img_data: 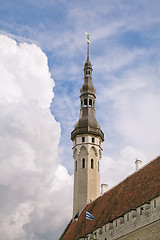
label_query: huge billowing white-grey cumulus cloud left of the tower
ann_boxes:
[0,35,72,240]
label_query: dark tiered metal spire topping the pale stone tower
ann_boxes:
[71,33,104,141]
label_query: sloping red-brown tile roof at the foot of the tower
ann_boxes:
[61,157,160,240]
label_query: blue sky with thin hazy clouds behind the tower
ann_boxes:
[0,0,160,239]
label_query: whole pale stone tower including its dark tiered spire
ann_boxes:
[71,35,104,216]
